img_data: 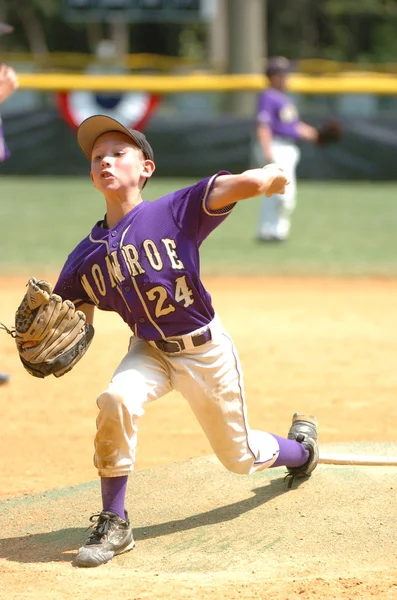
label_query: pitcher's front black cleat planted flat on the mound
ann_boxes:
[73,511,135,567]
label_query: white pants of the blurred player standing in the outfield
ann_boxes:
[255,138,300,240]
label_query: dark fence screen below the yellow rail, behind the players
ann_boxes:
[1,108,397,181]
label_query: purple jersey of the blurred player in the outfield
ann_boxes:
[256,88,299,140]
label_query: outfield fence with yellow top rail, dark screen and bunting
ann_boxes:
[2,57,397,180]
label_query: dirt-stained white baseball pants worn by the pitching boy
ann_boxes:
[94,318,279,477]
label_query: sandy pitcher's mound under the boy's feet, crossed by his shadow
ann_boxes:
[0,443,397,599]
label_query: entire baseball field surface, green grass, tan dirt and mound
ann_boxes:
[0,178,397,600]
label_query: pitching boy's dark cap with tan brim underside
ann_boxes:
[77,115,154,161]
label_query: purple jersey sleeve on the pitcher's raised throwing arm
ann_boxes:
[171,171,235,243]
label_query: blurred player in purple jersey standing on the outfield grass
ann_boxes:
[255,56,318,242]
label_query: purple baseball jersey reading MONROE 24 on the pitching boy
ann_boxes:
[54,171,234,341]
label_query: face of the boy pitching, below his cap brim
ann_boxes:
[91,131,154,194]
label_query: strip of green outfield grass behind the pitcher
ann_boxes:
[0,177,397,277]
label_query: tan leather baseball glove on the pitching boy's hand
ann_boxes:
[3,277,94,377]
